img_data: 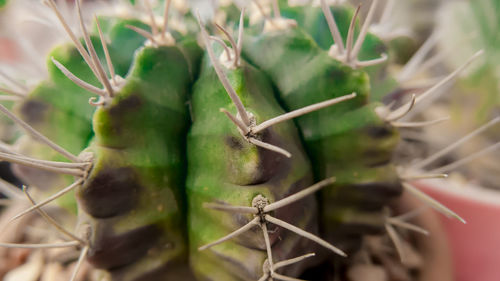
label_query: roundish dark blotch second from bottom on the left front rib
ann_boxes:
[78,167,141,218]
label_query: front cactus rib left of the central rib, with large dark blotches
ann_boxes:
[77,37,199,280]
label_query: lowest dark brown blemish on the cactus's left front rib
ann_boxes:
[88,220,161,269]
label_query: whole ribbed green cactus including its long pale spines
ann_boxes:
[0,0,490,281]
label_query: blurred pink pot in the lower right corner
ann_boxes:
[418,180,500,281]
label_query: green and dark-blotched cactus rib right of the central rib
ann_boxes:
[243,23,401,251]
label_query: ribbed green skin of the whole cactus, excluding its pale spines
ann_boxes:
[0,1,468,281]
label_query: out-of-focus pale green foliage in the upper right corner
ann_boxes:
[438,0,500,121]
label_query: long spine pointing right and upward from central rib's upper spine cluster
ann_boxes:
[251,93,356,133]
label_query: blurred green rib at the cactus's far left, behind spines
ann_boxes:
[14,17,146,213]
